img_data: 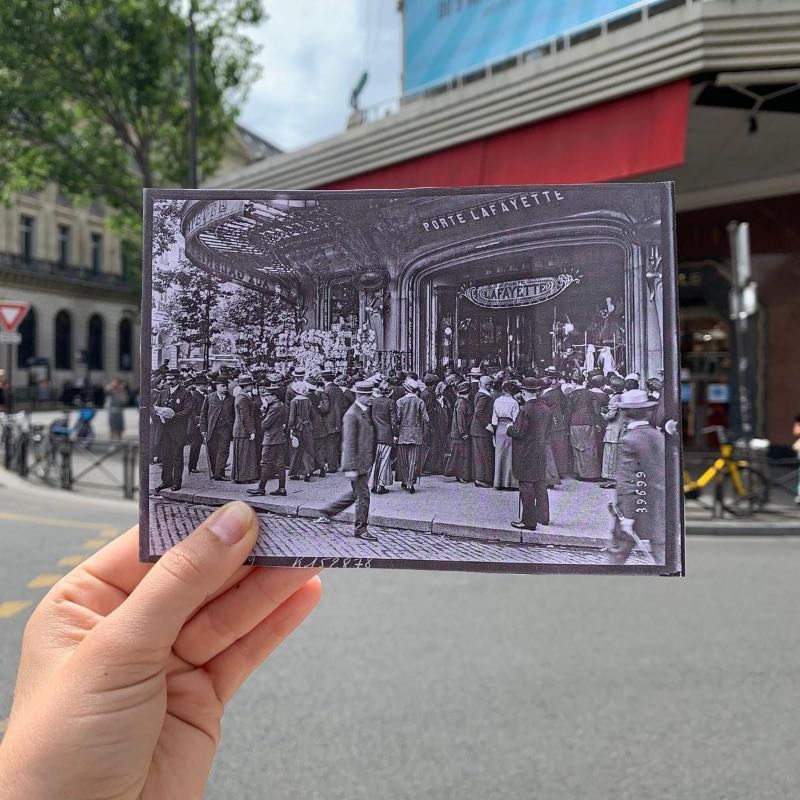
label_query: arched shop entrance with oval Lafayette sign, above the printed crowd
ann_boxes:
[421,244,630,370]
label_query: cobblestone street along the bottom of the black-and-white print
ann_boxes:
[150,499,648,567]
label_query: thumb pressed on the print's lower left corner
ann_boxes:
[98,501,258,655]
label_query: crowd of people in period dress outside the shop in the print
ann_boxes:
[151,366,669,563]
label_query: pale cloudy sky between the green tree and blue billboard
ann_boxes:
[240,0,402,150]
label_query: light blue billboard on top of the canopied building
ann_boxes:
[403,0,645,94]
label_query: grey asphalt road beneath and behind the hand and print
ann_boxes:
[0,478,800,800]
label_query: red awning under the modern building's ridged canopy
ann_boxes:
[317,79,689,189]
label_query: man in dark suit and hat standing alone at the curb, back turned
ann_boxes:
[506,378,552,531]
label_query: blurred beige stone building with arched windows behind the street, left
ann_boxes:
[0,126,280,402]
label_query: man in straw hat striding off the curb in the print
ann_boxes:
[316,381,378,542]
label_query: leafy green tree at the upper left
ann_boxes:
[0,0,263,238]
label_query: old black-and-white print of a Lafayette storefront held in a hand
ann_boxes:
[140,188,684,575]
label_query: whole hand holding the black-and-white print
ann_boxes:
[0,503,320,800]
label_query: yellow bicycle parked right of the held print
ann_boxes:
[683,425,769,517]
